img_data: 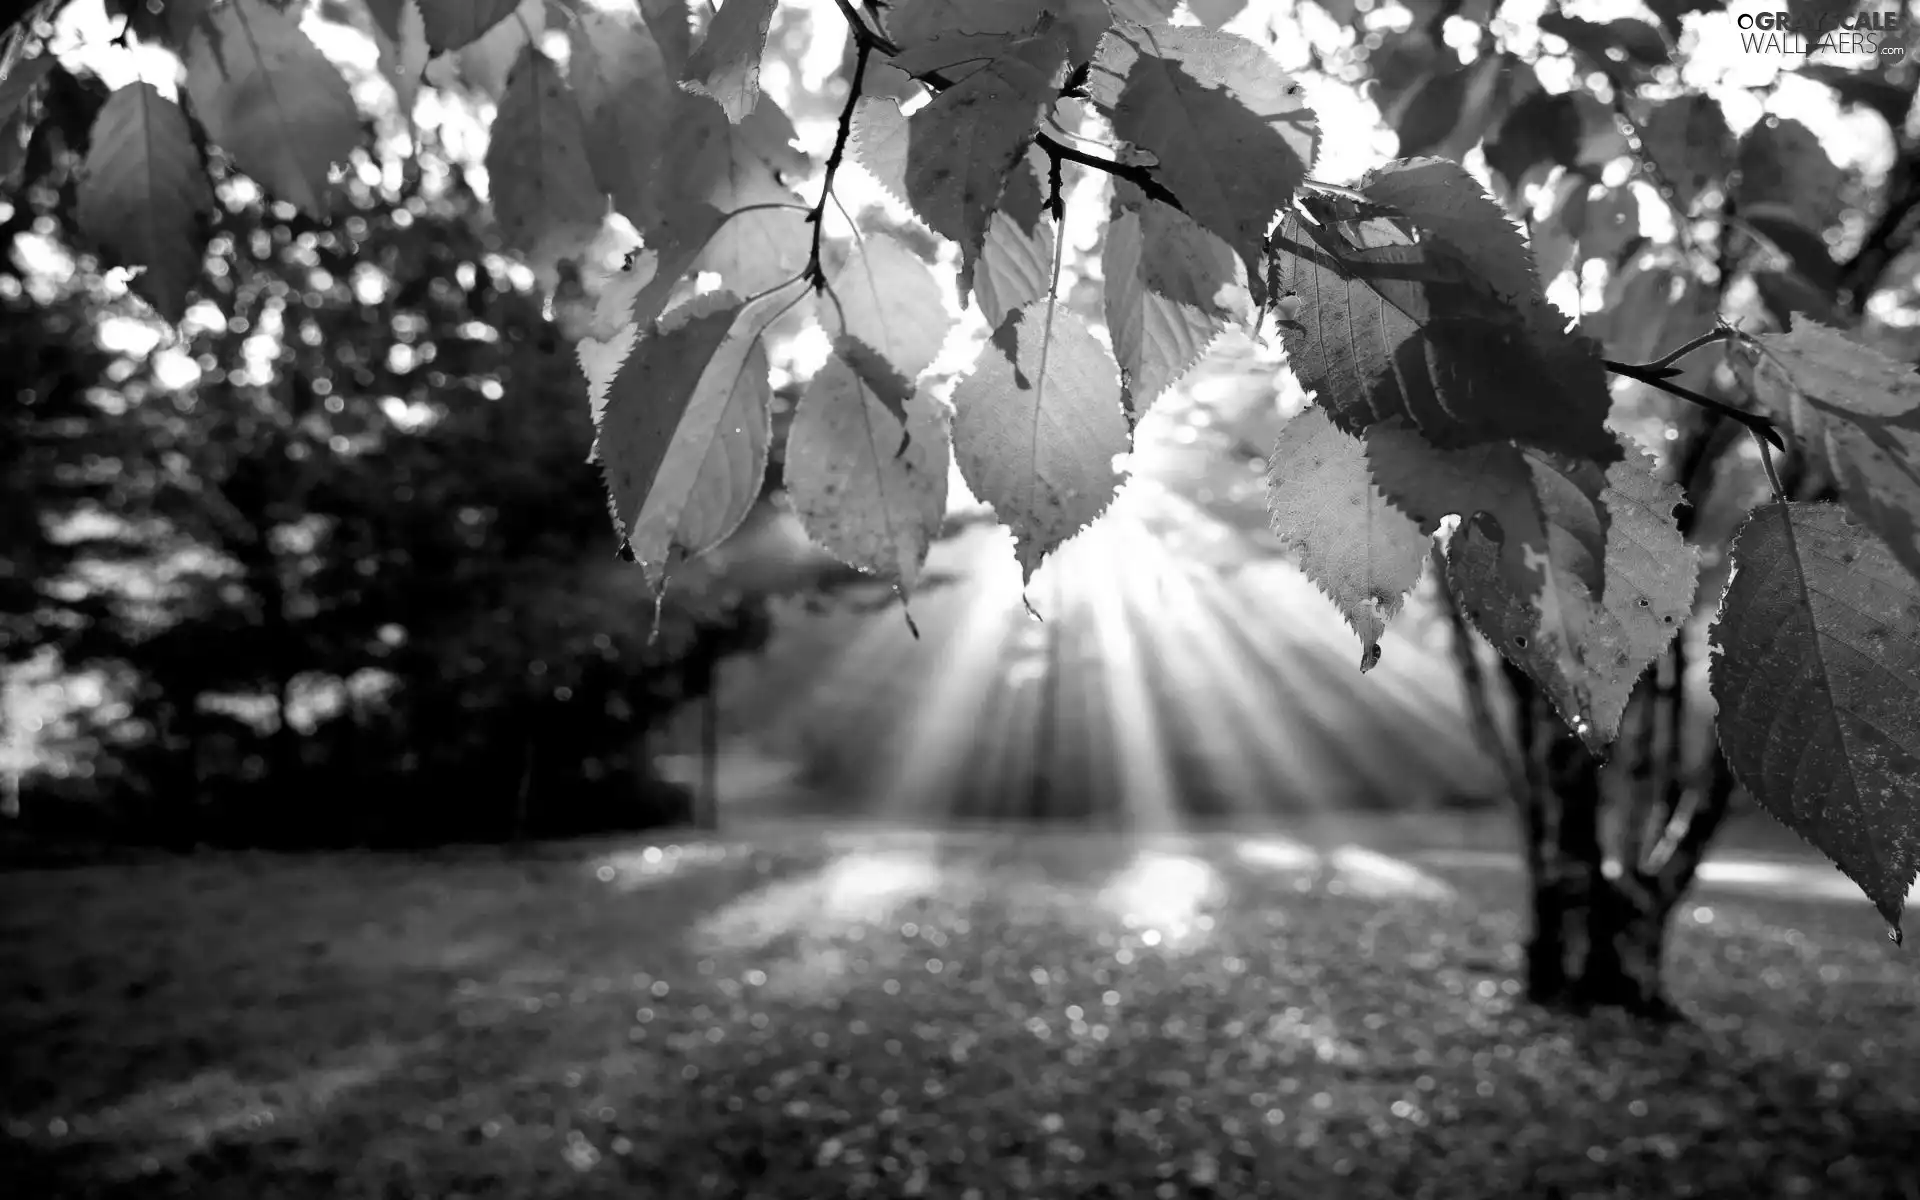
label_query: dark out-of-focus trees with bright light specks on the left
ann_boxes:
[0,63,783,845]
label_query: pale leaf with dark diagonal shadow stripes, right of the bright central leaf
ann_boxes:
[1100,180,1246,420]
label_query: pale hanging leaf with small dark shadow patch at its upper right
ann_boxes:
[783,349,948,593]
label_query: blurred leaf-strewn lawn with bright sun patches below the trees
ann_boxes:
[0,826,1920,1200]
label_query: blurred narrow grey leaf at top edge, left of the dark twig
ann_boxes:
[566,10,678,228]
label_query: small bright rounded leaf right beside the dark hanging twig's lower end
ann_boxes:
[820,234,954,378]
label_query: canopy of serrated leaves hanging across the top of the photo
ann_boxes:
[0,0,1920,922]
